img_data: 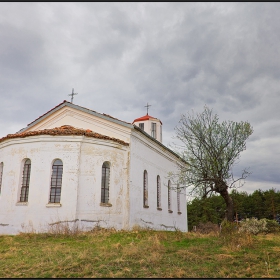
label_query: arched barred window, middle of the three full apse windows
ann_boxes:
[50,159,63,203]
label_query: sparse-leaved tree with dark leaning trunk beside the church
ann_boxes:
[171,106,253,221]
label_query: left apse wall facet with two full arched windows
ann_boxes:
[0,136,81,234]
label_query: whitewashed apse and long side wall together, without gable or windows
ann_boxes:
[0,127,187,234]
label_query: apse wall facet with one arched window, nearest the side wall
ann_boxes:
[77,139,128,230]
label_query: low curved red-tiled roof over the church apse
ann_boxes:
[0,125,129,146]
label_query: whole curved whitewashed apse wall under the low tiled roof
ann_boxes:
[0,135,128,234]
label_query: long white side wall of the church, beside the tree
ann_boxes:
[130,131,187,231]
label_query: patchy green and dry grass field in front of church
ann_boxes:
[0,229,280,278]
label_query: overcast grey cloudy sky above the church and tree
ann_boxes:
[0,3,280,193]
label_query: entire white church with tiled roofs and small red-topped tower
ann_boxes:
[0,100,188,234]
